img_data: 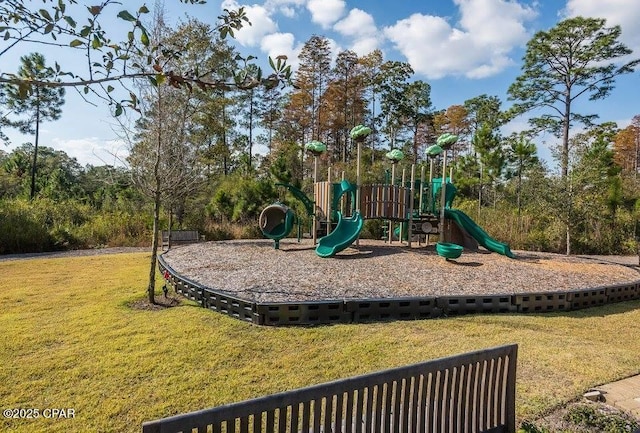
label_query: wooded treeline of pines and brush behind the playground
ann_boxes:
[0,15,640,254]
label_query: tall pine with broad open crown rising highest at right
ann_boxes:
[509,17,640,177]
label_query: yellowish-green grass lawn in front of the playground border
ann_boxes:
[0,253,640,433]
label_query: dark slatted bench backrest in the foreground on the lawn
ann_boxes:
[142,344,517,433]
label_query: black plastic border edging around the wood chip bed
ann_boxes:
[158,255,640,326]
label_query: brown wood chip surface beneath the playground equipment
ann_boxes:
[163,239,640,303]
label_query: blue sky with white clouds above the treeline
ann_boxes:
[0,0,640,165]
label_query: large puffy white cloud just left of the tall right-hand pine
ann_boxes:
[384,0,536,79]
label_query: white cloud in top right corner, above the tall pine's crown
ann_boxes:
[565,0,640,52]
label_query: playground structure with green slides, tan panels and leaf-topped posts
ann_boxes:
[260,127,513,259]
